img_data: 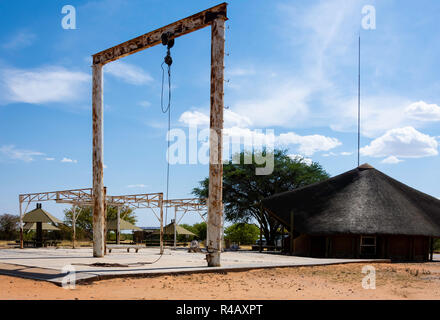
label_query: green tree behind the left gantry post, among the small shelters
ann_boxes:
[64,206,136,240]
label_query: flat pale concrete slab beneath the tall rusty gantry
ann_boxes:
[0,248,389,285]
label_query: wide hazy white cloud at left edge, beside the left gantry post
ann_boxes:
[0,67,90,104]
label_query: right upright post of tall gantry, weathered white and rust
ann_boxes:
[206,17,226,267]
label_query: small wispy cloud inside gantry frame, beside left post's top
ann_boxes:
[104,60,153,85]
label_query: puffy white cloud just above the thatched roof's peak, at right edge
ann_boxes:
[360,127,438,158]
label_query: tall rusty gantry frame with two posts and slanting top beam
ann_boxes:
[92,3,228,266]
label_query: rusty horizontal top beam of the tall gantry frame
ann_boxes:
[93,2,228,65]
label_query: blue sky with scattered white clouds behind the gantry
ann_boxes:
[0,0,440,226]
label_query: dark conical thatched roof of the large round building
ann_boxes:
[263,164,440,237]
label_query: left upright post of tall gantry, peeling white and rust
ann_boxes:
[92,64,105,257]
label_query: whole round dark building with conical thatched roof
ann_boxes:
[263,164,440,261]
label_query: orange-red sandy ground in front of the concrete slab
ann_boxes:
[0,262,440,300]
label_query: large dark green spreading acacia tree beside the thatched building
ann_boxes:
[192,150,329,244]
